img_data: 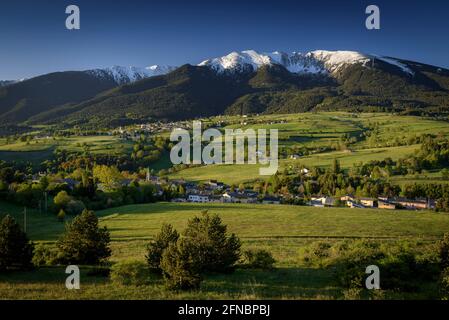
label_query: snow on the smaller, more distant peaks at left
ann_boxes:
[86,65,176,85]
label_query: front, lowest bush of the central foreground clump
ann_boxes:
[161,238,201,290]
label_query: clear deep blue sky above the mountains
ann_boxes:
[0,0,449,79]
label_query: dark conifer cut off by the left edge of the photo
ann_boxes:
[0,215,34,271]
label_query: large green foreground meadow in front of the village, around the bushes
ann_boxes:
[0,203,449,299]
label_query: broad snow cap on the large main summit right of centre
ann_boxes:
[199,50,413,75]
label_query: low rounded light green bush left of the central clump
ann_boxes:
[110,261,151,286]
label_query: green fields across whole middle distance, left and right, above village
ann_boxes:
[0,112,449,184]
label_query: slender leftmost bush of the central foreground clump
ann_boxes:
[146,224,179,273]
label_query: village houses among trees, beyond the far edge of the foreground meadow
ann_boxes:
[30,166,436,210]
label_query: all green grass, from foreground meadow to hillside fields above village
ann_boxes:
[0,112,449,299]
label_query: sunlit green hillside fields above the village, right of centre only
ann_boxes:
[170,112,449,185]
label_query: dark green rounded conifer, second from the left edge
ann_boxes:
[57,210,111,265]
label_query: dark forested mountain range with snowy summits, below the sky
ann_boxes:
[0,50,449,126]
